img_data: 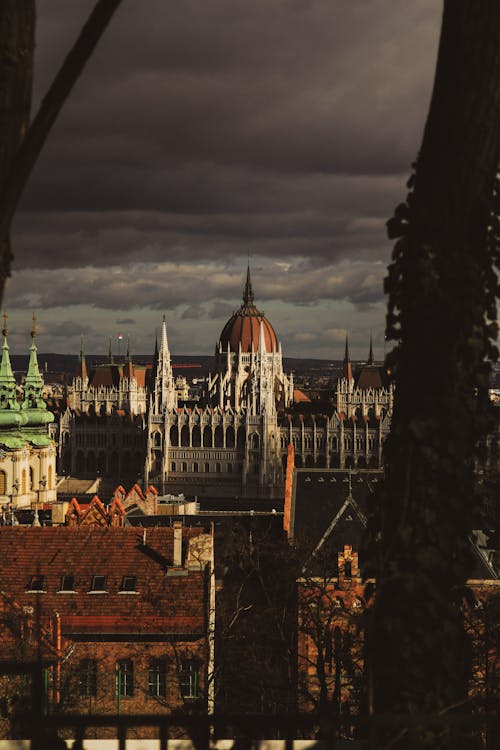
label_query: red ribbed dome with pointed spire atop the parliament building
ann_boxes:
[220,269,278,352]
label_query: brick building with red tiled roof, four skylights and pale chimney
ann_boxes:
[0,522,213,736]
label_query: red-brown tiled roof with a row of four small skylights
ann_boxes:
[0,526,205,644]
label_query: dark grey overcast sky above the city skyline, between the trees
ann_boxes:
[5,0,441,359]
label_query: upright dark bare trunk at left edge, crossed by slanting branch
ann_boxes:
[0,0,36,300]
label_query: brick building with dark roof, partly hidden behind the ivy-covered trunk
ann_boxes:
[284,446,500,736]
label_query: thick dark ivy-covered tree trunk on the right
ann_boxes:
[366,0,500,748]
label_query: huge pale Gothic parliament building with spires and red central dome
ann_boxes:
[53,269,393,498]
